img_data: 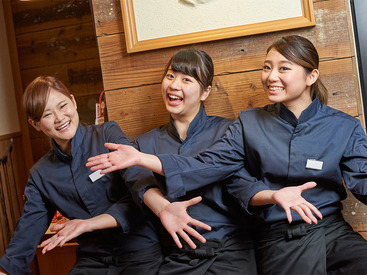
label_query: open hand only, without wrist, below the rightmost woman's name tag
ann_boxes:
[273,181,322,223]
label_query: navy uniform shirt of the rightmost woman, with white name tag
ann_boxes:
[159,98,367,226]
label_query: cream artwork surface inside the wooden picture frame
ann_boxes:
[133,0,302,41]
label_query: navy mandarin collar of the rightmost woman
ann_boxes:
[279,96,321,127]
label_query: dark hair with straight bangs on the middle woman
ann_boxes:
[162,49,214,90]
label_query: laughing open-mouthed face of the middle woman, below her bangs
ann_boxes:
[161,69,210,121]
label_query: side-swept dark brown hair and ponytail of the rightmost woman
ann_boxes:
[267,35,328,104]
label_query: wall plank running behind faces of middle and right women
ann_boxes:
[106,58,358,140]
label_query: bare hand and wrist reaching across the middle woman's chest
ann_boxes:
[86,143,163,175]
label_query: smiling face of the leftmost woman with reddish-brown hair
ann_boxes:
[28,89,79,154]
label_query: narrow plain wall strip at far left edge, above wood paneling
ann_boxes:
[0,2,20,136]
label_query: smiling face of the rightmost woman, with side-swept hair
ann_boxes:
[261,49,318,117]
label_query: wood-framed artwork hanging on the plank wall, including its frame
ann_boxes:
[120,0,315,53]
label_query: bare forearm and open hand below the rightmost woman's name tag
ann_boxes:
[250,181,322,223]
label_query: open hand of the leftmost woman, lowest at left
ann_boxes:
[41,219,90,254]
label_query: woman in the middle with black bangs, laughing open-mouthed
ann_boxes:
[125,49,256,274]
